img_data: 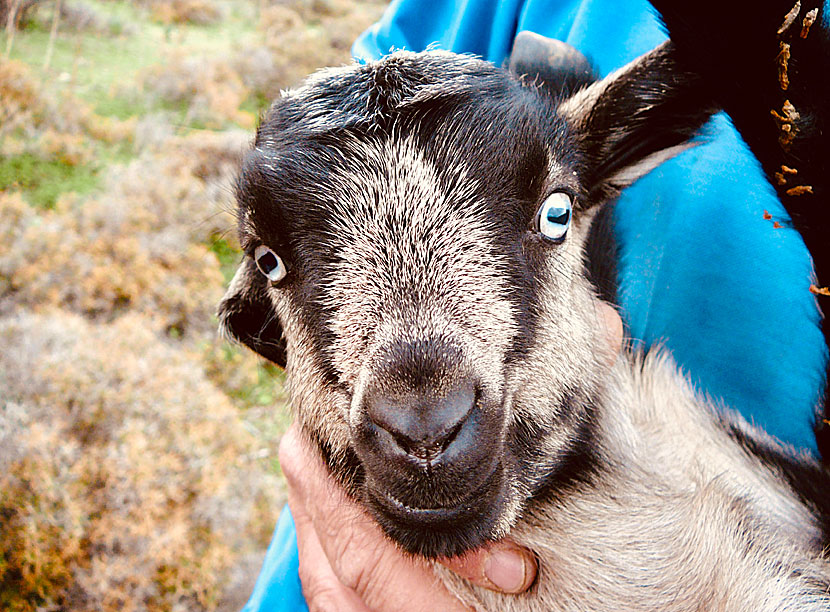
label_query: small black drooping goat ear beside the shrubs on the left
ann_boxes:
[217,258,286,368]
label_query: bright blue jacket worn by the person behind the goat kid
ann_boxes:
[240,0,826,612]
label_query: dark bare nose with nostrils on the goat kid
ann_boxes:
[366,381,476,462]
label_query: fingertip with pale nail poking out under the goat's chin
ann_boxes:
[440,540,538,594]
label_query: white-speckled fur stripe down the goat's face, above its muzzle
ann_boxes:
[308,138,515,402]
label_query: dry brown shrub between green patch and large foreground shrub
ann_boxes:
[0,196,222,333]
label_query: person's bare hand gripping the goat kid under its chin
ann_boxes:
[280,425,537,612]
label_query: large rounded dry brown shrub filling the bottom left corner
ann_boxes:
[0,312,279,612]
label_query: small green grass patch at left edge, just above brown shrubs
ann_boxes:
[0,153,99,208]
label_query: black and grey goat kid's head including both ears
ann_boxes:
[220,47,707,556]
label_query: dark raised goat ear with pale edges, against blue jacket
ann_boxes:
[559,42,717,202]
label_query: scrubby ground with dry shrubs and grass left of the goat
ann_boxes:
[0,0,382,612]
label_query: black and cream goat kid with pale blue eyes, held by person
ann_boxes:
[220,5,830,612]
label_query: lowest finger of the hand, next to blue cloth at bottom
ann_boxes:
[289,486,369,612]
